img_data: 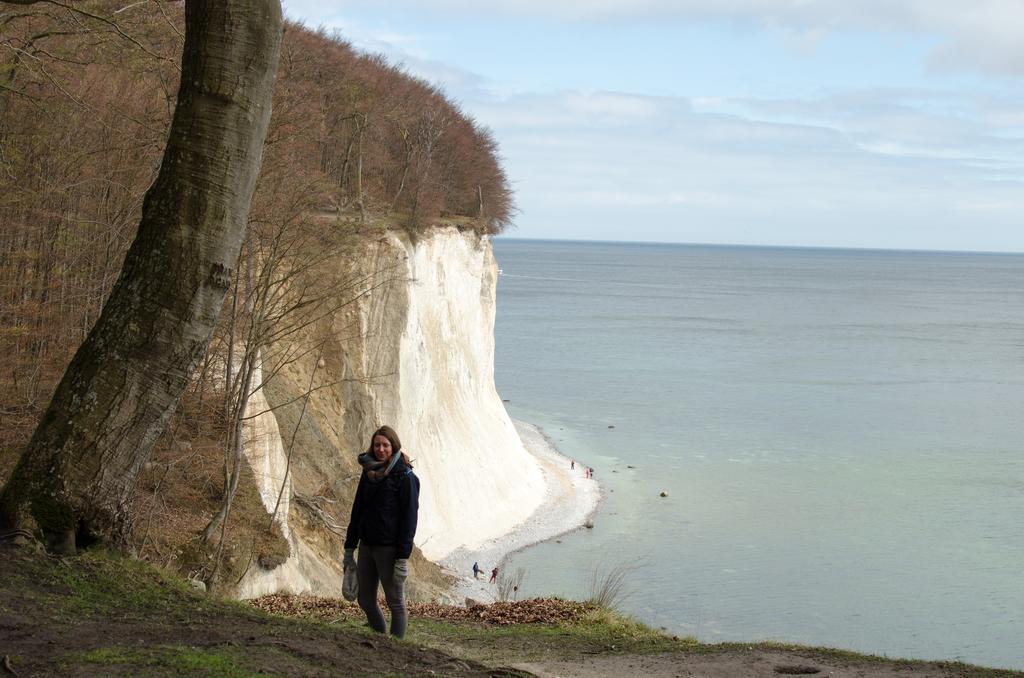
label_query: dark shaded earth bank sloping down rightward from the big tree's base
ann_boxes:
[0,546,522,676]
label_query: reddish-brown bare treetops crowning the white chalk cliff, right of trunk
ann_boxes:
[271,25,512,234]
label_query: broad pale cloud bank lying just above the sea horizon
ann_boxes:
[480,84,1024,250]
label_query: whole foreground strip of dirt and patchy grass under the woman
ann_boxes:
[0,539,1024,678]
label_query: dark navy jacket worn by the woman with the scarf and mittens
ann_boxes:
[345,459,420,558]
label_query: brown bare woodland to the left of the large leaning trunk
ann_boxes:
[0,3,181,464]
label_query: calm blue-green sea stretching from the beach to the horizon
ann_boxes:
[495,239,1024,669]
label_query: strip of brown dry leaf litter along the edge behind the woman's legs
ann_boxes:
[248,593,595,626]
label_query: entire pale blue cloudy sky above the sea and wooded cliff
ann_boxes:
[284,0,1024,252]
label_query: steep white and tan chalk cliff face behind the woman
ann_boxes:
[239,227,544,597]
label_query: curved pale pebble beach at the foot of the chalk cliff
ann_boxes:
[437,420,602,605]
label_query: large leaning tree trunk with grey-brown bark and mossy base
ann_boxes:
[0,0,282,552]
